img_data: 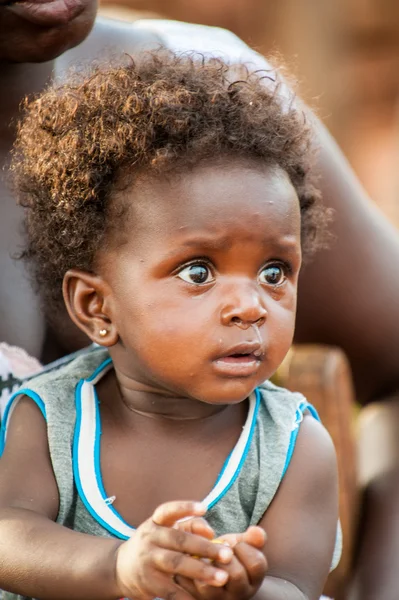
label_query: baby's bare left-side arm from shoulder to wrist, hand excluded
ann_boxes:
[0,399,123,599]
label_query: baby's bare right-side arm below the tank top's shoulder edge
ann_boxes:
[255,416,338,600]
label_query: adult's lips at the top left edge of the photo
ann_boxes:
[5,0,87,27]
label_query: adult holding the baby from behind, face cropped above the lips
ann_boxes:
[0,0,399,600]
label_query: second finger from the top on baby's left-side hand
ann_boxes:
[153,527,233,564]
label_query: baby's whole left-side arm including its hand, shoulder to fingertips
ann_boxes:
[0,398,232,600]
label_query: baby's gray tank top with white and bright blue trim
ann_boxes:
[0,348,342,600]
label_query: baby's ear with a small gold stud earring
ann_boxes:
[62,269,119,346]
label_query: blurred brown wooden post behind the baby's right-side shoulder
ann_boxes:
[277,345,359,600]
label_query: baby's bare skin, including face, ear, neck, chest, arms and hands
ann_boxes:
[0,162,338,600]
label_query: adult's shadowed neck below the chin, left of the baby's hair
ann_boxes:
[0,61,54,150]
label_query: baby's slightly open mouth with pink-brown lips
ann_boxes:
[213,341,265,377]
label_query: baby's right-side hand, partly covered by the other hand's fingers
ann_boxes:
[177,527,267,600]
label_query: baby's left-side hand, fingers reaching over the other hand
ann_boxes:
[115,501,233,600]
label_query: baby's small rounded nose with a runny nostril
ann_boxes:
[220,284,267,329]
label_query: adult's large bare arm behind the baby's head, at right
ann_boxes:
[296,117,399,403]
